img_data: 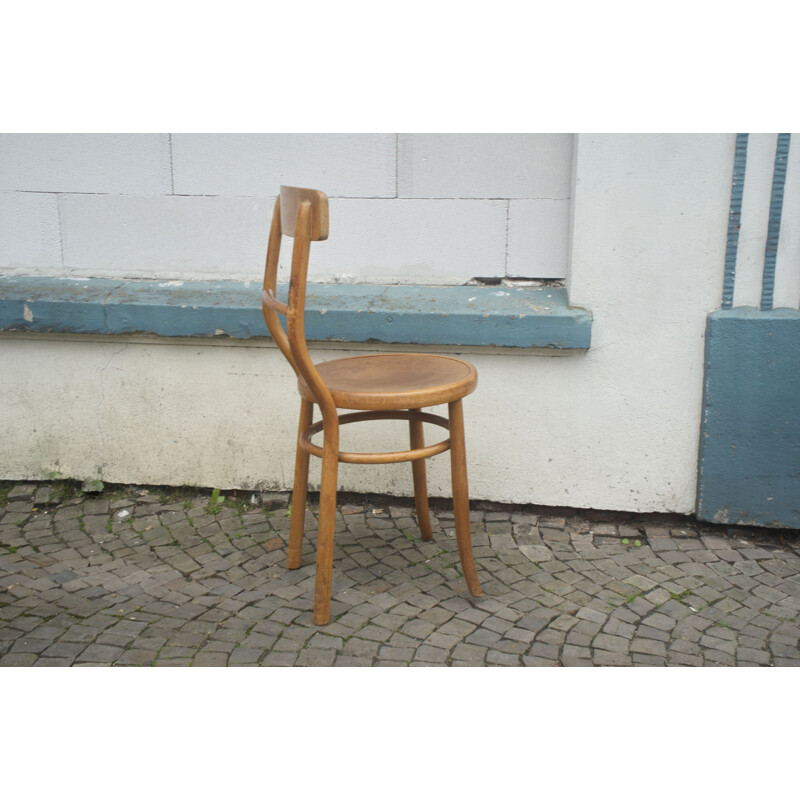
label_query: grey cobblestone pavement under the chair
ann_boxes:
[0,484,800,667]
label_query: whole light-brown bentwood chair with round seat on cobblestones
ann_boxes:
[262,186,483,625]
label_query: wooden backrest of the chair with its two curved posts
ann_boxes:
[261,186,336,418]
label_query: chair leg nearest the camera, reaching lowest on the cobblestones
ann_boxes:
[314,419,339,625]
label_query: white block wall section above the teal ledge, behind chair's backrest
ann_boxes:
[0,133,574,284]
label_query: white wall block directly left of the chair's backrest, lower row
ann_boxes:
[61,195,274,280]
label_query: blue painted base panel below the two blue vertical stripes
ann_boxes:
[697,308,800,528]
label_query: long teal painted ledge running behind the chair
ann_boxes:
[0,276,592,350]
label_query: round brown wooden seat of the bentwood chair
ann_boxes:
[297,353,478,410]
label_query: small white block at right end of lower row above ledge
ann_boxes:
[507,200,571,278]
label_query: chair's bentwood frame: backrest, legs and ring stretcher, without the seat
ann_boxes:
[262,186,483,625]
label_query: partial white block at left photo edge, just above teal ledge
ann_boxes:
[0,192,61,272]
